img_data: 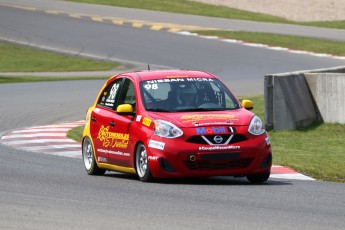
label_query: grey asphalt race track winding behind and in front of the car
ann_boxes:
[0,0,345,229]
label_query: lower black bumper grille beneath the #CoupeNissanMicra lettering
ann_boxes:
[184,158,253,170]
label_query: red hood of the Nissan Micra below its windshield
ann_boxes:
[150,109,254,128]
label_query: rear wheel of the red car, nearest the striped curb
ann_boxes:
[82,137,105,175]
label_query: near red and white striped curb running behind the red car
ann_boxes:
[0,121,314,180]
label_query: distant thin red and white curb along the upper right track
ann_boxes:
[177,31,345,60]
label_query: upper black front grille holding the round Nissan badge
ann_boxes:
[186,134,247,145]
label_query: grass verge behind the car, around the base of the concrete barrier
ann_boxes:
[67,96,345,183]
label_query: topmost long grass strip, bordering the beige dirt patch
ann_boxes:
[69,0,345,29]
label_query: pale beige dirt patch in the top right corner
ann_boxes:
[194,0,345,21]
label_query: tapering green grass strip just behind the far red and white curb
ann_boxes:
[196,30,345,56]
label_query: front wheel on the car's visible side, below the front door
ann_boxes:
[135,143,153,182]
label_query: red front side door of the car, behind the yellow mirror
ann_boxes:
[108,78,136,167]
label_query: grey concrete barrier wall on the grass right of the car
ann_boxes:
[265,67,345,130]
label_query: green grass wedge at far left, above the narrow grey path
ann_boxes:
[0,42,120,72]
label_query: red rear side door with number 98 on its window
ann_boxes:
[90,78,124,163]
